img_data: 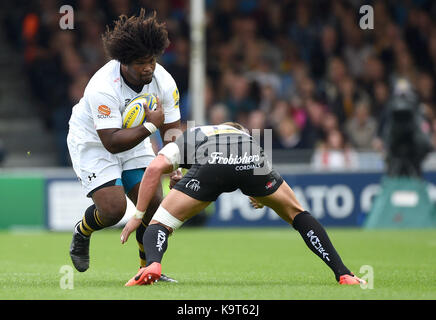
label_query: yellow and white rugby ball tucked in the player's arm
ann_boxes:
[123,93,157,128]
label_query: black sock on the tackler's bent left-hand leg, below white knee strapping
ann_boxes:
[142,224,170,266]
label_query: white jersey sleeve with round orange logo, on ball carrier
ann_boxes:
[87,91,123,130]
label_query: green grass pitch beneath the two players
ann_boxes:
[0,228,436,300]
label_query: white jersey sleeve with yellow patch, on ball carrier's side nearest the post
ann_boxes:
[161,73,180,123]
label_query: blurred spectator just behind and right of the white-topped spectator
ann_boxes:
[345,101,377,150]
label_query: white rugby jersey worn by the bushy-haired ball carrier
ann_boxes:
[69,60,180,144]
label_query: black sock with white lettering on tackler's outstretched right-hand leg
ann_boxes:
[292,211,351,281]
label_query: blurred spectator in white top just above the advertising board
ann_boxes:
[312,130,358,170]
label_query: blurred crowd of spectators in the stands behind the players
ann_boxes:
[2,0,436,168]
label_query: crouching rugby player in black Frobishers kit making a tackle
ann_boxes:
[121,123,365,286]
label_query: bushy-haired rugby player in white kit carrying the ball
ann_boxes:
[67,9,180,281]
